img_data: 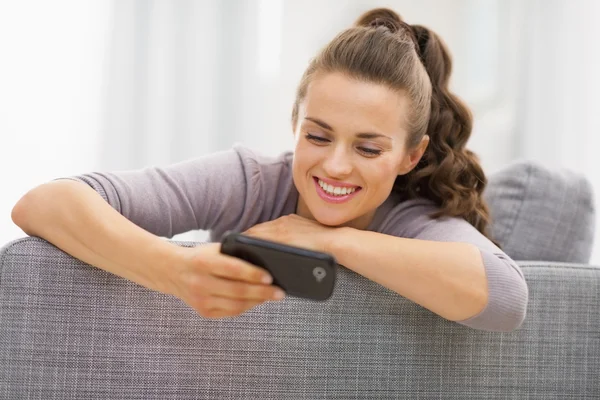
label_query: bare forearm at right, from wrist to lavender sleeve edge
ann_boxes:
[327,228,488,321]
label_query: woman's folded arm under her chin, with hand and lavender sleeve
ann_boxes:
[245,200,528,332]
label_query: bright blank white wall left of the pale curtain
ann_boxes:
[0,0,112,244]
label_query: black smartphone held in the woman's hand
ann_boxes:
[221,231,337,301]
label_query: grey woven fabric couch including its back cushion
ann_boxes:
[0,162,600,399]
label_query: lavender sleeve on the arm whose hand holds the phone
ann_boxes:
[54,145,296,238]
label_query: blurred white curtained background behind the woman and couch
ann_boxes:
[0,0,600,264]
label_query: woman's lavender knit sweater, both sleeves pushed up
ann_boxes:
[63,144,528,331]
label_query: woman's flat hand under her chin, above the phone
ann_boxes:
[244,214,339,252]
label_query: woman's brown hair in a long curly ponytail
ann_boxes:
[292,8,498,245]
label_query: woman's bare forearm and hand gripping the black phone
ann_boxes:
[12,180,286,318]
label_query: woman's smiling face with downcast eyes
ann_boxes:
[293,73,428,229]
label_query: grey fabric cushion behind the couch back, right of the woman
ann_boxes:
[484,161,595,263]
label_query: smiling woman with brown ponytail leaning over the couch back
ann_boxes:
[12,9,528,331]
